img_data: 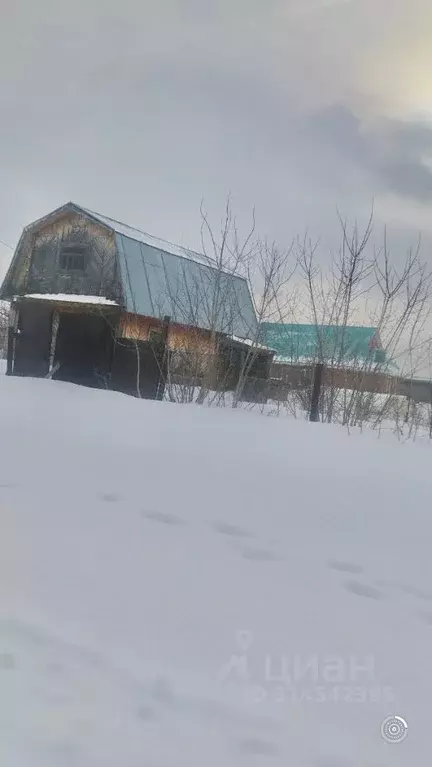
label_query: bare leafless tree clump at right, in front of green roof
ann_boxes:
[292,213,431,426]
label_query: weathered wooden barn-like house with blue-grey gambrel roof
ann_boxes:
[0,202,273,398]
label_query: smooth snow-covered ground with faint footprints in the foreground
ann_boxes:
[0,376,432,767]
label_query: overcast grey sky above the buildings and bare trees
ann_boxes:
[0,0,432,272]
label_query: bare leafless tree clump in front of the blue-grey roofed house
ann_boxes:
[160,199,296,407]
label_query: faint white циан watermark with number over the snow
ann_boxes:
[222,630,394,704]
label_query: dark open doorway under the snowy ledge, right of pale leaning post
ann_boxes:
[53,313,114,388]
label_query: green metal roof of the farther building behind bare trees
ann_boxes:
[261,322,386,364]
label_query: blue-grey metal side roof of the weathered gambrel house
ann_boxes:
[78,206,258,338]
